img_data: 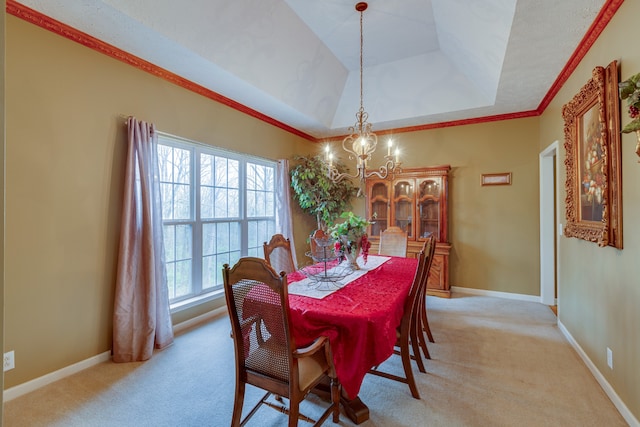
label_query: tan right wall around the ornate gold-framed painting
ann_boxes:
[539,1,640,419]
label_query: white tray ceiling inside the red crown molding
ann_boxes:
[19,0,605,138]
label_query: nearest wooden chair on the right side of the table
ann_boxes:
[369,251,427,399]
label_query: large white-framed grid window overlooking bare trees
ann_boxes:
[158,134,275,304]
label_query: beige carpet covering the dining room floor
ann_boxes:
[4,294,627,427]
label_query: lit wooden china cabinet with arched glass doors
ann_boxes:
[366,165,451,298]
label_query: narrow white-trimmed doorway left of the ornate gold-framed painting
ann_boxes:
[540,141,560,306]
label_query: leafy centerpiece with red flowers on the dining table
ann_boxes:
[329,212,371,269]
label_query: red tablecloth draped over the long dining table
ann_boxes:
[288,257,418,398]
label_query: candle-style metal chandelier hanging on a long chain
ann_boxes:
[325,2,400,191]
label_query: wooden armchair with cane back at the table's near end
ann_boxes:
[222,257,340,427]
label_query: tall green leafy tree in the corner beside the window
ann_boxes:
[290,156,357,230]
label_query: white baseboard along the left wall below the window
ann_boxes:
[2,306,227,402]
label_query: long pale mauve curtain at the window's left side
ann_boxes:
[113,117,173,362]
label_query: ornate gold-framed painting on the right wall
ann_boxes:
[562,61,622,249]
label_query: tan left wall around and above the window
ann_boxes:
[5,16,312,388]
